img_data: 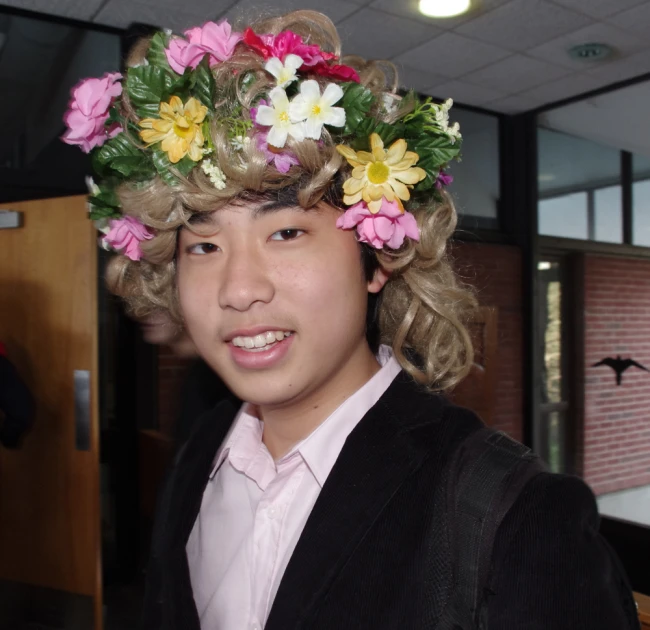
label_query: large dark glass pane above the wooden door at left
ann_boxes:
[0,13,121,202]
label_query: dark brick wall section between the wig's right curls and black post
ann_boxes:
[453,243,523,440]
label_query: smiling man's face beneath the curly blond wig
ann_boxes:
[177,203,383,408]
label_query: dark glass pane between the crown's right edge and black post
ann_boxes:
[449,108,500,220]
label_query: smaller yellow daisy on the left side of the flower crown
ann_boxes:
[140,96,208,164]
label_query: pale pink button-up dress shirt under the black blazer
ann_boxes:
[186,346,401,630]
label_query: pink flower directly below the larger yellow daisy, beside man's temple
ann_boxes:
[336,197,420,249]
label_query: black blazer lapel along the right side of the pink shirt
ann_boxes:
[265,373,440,630]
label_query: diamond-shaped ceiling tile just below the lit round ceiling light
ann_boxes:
[394,33,509,79]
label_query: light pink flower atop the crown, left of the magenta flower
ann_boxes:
[165,20,242,74]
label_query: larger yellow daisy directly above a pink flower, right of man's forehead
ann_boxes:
[336,133,427,214]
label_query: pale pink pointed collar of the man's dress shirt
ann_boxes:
[210,345,402,487]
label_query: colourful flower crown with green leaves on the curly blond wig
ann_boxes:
[62,21,461,260]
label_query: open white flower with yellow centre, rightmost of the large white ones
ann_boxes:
[289,79,345,140]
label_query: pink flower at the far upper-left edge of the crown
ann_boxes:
[61,72,122,153]
